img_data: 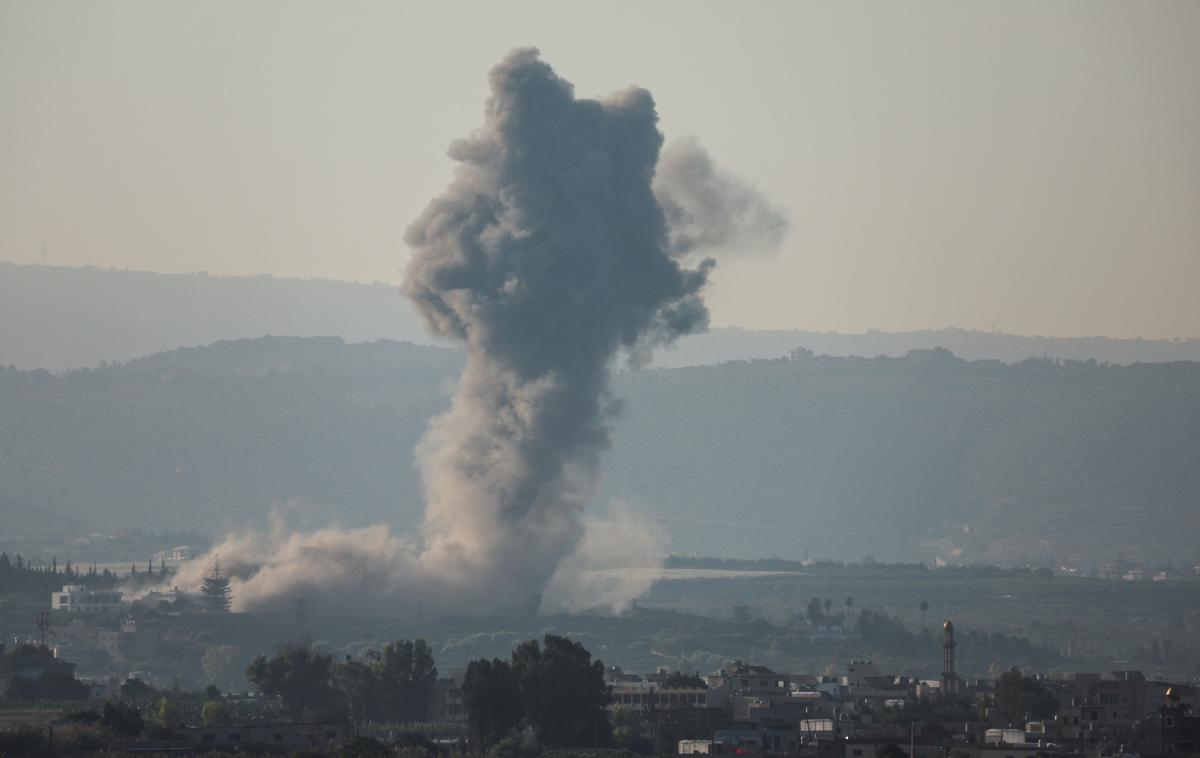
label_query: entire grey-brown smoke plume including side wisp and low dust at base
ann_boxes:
[162,49,781,614]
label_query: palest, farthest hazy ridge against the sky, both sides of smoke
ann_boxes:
[0,261,1200,371]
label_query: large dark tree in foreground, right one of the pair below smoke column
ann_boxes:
[512,634,612,747]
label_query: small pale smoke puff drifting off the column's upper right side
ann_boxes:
[654,138,788,255]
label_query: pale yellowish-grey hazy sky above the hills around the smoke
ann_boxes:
[0,0,1200,337]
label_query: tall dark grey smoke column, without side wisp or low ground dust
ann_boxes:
[403,49,713,603]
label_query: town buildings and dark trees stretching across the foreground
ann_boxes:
[0,546,1200,758]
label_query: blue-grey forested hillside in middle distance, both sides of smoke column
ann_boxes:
[0,338,1200,563]
